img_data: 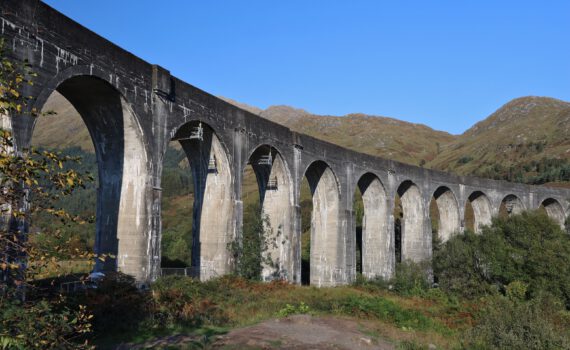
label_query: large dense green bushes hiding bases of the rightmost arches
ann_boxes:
[434,212,570,307]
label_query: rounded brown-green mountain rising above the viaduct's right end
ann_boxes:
[427,97,570,183]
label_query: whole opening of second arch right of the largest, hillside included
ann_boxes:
[242,145,293,281]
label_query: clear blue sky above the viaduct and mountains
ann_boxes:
[45,0,570,134]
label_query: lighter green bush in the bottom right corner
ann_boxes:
[464,296,570,350]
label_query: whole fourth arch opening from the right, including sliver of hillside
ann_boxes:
[430,186,461,243]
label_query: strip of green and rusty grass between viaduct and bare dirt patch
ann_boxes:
[99,276,470,348]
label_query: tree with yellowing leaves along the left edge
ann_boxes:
[0,41,92,348]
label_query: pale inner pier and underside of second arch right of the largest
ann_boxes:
[248,144,294,281]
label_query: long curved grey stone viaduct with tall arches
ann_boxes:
[0,0,570,286]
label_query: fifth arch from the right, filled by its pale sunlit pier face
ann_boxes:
[397,180,431,262]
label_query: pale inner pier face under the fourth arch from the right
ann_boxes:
[432,186,461,243]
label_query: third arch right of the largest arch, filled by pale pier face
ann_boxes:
[305,161,344,287]
